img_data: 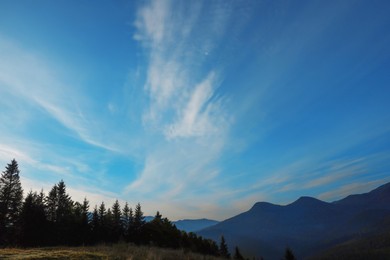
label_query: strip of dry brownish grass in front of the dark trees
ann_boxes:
[0,244,224,260]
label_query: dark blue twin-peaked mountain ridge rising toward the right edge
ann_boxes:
[197,183,390,259]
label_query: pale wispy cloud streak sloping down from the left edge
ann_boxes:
[0,37,115,150]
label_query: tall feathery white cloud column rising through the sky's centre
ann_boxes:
[127,1,231,203]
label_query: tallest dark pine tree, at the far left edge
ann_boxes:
[0,159,23,244]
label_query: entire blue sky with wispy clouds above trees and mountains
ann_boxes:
[0,0,390,220]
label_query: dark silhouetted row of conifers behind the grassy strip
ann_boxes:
[0,159,250,259]
